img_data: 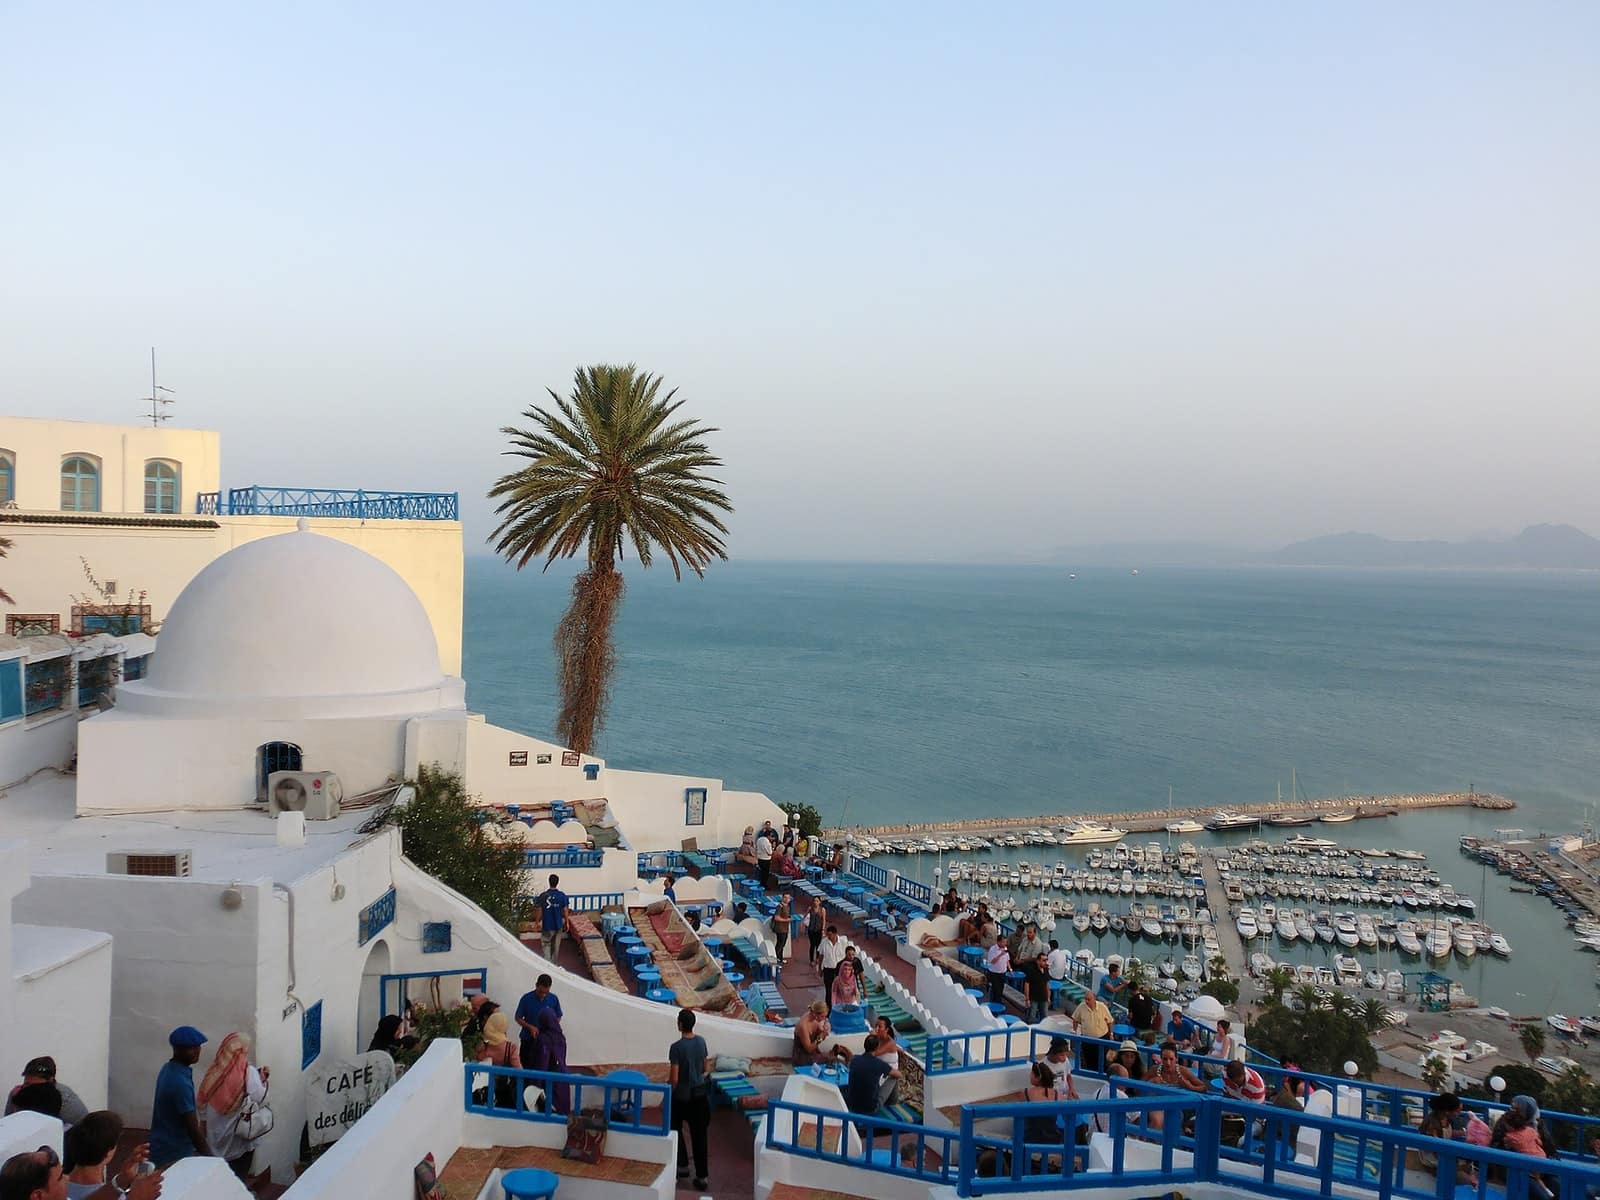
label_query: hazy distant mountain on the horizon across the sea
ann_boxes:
[1256,525,1600,571]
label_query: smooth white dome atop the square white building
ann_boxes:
[118,522,464,717]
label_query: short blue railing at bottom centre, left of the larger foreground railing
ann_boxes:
[766,1101,960,1184]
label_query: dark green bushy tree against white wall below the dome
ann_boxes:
[366,763,531,933]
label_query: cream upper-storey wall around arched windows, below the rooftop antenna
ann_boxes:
[0,416,222,518]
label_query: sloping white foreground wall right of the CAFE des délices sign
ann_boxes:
[293,1040,464,1200]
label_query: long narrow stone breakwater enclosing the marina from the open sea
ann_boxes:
[822,792,1517,837]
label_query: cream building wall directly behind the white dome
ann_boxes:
[0,508,462,675]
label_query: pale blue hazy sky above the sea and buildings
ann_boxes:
[0,0,1600,558]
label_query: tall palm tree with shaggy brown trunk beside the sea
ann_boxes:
[490,363,733,754]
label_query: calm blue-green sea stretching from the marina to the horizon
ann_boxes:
[462,557,1600,1017]
